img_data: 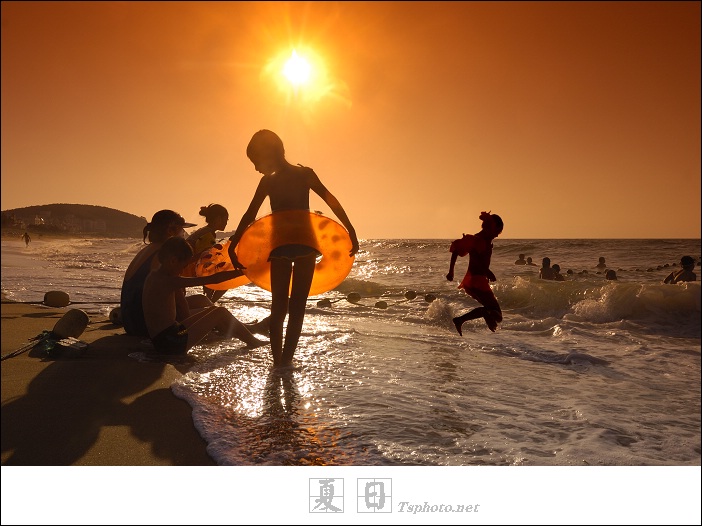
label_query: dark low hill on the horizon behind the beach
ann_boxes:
[2,204,147,237]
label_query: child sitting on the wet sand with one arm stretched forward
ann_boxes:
[142,237,266,354]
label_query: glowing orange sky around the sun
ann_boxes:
[2,1,700,239]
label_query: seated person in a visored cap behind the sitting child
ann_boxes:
[120,210,212,337]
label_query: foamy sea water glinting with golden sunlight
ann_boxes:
[2,238,702,466]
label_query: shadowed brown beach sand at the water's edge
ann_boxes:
[2,297,215,466]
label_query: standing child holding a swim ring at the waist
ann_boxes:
[229,130,358,366]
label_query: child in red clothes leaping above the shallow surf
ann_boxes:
[446,212,504,336]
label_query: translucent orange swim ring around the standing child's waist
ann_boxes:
[236,210,354,296]
